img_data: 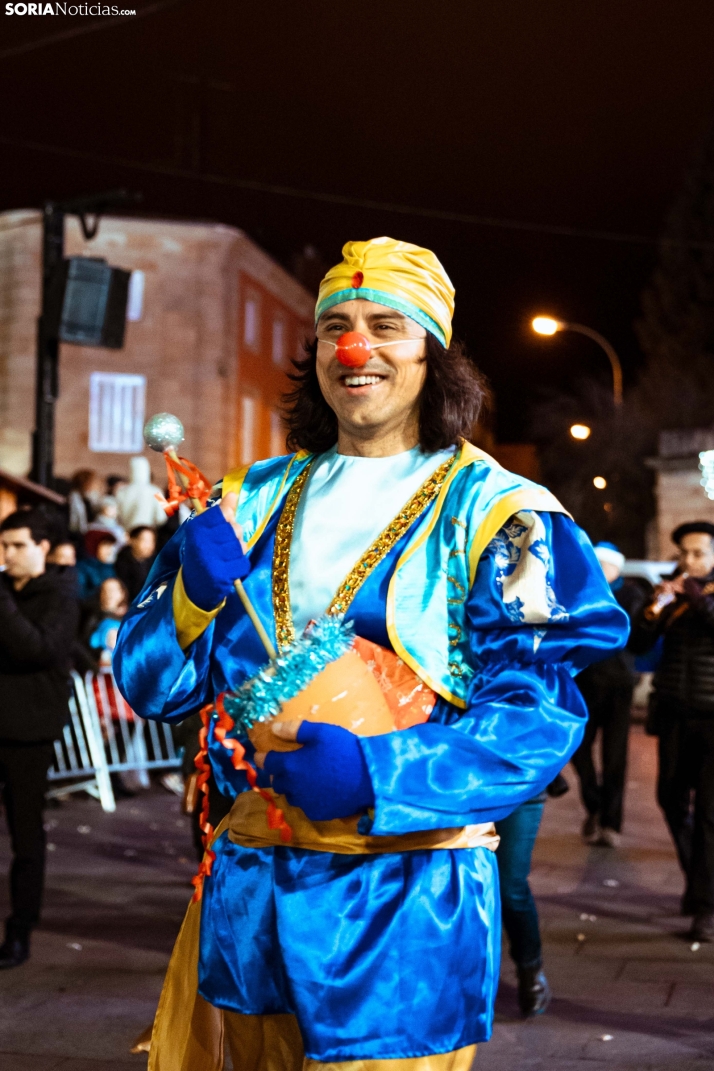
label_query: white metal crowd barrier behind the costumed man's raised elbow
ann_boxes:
[47,668,181,811]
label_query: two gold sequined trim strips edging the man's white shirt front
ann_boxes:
[273,454,456,649]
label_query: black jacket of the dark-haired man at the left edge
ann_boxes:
[0,567,79,742]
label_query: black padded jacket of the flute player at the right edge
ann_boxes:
[633,573,714,718]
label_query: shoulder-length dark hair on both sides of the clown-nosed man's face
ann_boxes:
[283,332,488,454]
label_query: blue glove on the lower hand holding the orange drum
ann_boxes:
[264,722,375,821]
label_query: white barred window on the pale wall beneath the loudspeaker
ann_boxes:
[89,372,147,454]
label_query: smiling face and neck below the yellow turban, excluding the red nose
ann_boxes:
[317,299,426,457]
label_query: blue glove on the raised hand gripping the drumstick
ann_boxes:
[182,506,250,609]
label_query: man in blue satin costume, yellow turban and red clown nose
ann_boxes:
[115,238,627,1071]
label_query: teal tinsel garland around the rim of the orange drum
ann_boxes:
[224,614,354,736]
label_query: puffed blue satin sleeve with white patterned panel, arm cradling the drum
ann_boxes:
[361,511,628,835]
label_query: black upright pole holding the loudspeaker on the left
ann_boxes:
[32,201,64,487]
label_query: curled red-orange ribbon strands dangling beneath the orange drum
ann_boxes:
[192,692,292,902]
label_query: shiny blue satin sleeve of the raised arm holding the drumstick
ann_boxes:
[111,526,214,722]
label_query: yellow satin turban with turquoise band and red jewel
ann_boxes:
[315,238,454,346]
